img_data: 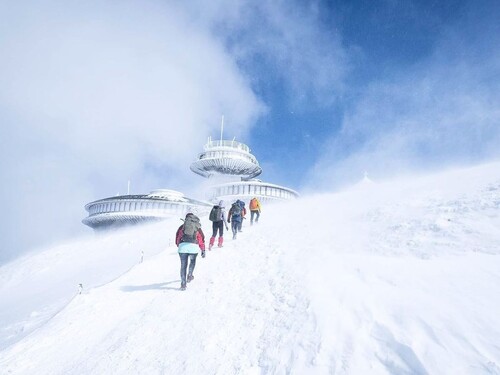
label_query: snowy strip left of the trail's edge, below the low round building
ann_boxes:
[0,220,178,349]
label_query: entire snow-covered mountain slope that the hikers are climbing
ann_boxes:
[0,163,500,374]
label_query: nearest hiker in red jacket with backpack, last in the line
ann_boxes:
[175,213,205,290]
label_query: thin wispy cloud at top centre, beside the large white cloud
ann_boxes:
[186,0,350,110]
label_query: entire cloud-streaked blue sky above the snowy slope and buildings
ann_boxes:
[0,0,500,259]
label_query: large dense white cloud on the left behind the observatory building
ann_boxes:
[0,2,263,257]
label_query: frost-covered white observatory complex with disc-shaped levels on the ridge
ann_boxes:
[82,136,298,229]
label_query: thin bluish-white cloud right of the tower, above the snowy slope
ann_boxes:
[308,16,500,188]
